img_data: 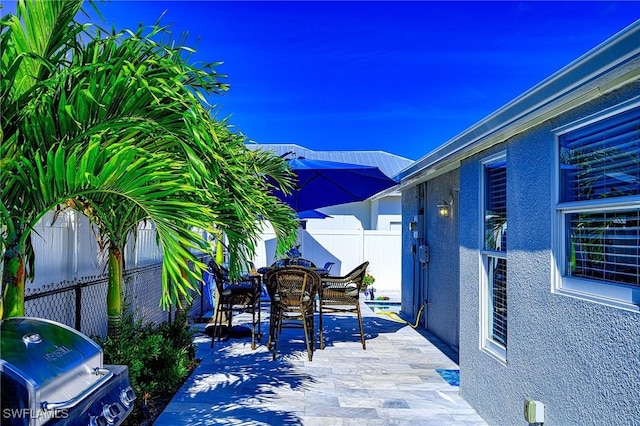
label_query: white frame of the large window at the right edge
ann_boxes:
[551,97,640,312]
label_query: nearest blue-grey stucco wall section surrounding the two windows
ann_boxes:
[460,84,640,425]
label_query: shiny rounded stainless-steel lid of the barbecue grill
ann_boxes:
[0,318,102,388]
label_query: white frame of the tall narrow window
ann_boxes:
[478,151,509,365]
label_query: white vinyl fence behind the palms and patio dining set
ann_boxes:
[25,211,401,335]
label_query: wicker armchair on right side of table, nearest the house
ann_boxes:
[318,262,369,350]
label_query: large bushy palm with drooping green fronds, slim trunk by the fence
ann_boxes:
[0,1,295,330]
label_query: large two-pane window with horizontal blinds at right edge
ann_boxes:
[556,105,640,310]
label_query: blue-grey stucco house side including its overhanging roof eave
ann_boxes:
[399,21,640,426]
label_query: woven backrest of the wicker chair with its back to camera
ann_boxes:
[265,266,320,306]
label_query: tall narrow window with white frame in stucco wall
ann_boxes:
[480,154,507,361]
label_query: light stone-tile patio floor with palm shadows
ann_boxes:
[154,307,486,426]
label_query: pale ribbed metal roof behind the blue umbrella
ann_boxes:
[246,143,413,178]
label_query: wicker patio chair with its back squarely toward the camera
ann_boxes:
[265,266,320,361]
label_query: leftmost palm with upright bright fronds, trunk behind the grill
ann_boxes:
[0,0,90,317]
